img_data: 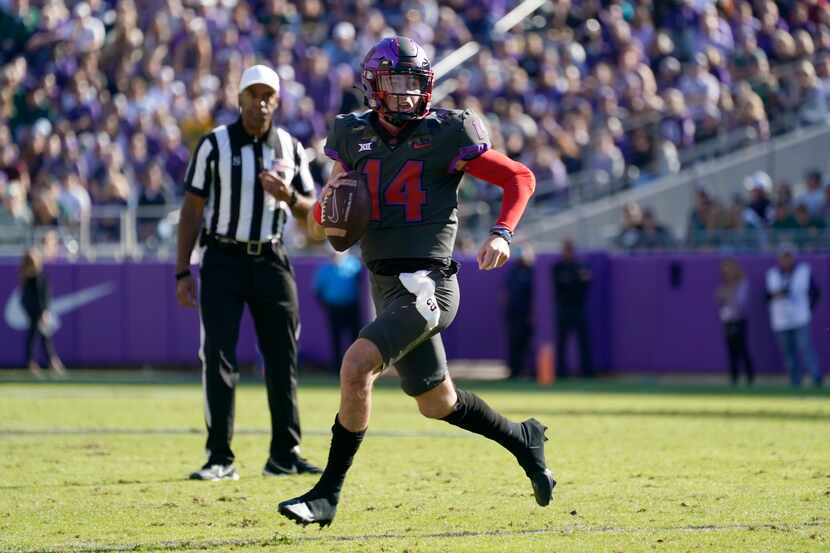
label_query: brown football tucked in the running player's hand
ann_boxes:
[322,171,370,252]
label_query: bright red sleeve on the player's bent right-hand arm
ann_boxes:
[464,150,536,232]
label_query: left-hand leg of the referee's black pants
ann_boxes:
[199,251,243,465]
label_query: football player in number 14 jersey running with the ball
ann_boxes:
[279,37,556,526]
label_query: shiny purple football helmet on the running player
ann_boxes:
[360,36,433,126]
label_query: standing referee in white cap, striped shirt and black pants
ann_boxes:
[176,65,320,480]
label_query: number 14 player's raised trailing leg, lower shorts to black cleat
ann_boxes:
[396,334,556,506]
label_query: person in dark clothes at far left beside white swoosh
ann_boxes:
[20,248,66,378]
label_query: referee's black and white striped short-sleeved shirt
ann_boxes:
[185,118,314,242]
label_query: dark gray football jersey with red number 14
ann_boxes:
[326,109,490,263]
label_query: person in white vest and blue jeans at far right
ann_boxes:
[766,244,823,388]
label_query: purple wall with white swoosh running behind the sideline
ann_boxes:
[0,253,830,374]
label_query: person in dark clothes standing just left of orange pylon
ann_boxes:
[503,244,535,379]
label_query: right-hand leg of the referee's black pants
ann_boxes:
[248,246,301,463]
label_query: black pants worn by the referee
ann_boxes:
[199,244,300,465]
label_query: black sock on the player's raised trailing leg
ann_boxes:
[442,390,527,461]
